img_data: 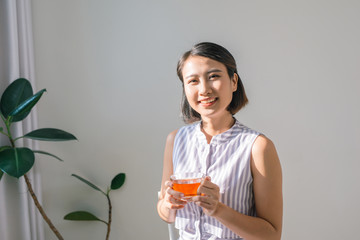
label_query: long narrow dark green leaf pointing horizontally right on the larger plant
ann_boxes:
[24,128,77,141]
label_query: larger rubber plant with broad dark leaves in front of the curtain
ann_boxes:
[0,78,76,240]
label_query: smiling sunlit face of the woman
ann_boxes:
[182,56,238,119]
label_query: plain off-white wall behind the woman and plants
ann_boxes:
[33,0,360,240]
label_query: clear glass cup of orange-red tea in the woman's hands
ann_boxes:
[170,172,205,199]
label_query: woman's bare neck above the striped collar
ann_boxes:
[201,113,235,143]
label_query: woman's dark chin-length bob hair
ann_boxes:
[177,42,248,123]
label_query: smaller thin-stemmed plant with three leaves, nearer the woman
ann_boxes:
[64,173,125,240]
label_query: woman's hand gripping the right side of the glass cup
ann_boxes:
[192,176,220,216]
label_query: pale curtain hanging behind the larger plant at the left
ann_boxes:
[0,0,44,240]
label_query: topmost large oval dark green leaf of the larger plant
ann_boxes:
[0,78,33,122]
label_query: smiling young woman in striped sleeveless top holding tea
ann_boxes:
[157,42,283,240]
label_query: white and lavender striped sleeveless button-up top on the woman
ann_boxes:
[173,120,260,240]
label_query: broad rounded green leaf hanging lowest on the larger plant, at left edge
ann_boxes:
[0,148,35,178]
